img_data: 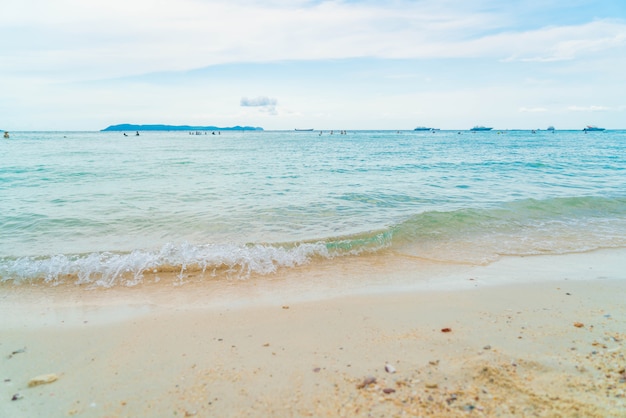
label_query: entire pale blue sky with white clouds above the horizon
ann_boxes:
[0,0,626,131]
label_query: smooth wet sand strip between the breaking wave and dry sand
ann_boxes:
[0,248,626,316]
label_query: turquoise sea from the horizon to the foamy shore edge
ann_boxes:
[0,131,626,286]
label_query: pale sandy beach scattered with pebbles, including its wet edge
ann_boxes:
[0,250,626,417]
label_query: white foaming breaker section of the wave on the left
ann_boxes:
[0,233,390,287]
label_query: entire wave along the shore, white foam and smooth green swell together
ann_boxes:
[0,196,626,287]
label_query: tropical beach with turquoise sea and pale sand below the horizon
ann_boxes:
[0,130,626,417]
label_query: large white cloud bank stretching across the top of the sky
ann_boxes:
[0,0,626,79]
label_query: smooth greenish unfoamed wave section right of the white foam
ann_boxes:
[393,196,626,264]
